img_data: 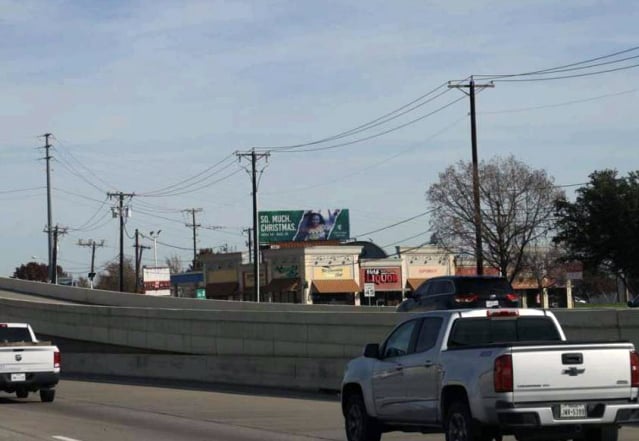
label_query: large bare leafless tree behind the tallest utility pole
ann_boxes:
[427,156,563,281]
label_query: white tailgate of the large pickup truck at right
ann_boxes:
[512,343,632,403]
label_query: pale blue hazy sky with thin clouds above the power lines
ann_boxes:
[0,0,639,277]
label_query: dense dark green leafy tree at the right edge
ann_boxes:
[554,169,639,294]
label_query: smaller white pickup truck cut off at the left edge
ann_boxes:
[0,323,60,402]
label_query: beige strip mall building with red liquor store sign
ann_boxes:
[196,242,458,306]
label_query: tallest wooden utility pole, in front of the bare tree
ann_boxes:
[448,76,495,276]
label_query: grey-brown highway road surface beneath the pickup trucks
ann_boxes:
[0,379,639,441]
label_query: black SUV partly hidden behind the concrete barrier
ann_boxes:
[397,276,519,312]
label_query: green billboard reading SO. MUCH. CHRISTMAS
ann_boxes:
[259,208,350,243]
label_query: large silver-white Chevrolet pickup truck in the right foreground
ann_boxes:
[341,309,639,441]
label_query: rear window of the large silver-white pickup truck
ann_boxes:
[448,317,561,347]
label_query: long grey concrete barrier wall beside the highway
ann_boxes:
[0,280,639,390]
